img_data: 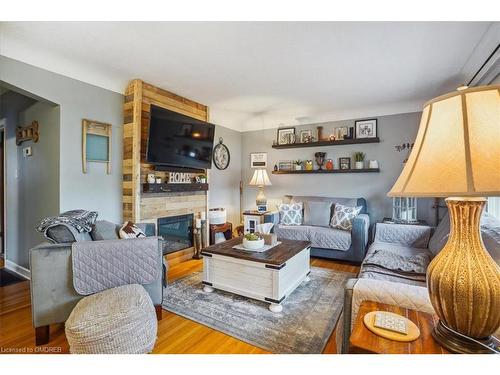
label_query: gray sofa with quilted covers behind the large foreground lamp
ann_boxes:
[337,213,500,353]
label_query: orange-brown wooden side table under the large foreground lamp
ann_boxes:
[349,301,449,354]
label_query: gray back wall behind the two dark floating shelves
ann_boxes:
[242,112,433,224]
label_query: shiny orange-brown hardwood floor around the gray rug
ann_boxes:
[0,258,359,354]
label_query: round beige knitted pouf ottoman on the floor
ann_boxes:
[65,284,158,354]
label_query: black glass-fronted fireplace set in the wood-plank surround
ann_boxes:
[158,214,194,254]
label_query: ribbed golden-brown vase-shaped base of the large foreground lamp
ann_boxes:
[427,198,500,353]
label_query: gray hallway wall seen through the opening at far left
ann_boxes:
[14,102,59,268]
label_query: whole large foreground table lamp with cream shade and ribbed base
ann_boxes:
[388,85,500,353]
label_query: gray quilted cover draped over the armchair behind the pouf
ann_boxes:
[71,237,162,296]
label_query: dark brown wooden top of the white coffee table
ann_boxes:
[201,236,311,266]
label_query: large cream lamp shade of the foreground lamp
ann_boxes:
[389,85,500,197]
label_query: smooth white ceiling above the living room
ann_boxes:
[0,22,492,130]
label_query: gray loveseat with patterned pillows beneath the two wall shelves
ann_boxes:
[271,195,370,263]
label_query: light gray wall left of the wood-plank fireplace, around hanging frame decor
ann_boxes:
[0,56,123,222]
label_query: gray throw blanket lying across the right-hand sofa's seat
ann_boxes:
[363,250,430,282]
